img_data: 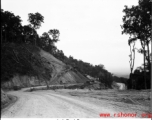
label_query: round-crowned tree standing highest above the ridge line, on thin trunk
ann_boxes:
[28,12,44,45]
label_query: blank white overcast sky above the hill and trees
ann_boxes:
[1,0,143,76]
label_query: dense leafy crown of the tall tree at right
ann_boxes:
[122,0,151,39]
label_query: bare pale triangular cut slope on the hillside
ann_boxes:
[39,49,88,84]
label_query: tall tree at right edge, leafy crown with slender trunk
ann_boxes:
[121,0,152,88]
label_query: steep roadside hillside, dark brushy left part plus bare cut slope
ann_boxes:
[1,43,87,88]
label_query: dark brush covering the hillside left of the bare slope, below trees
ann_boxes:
[1,43,52,82]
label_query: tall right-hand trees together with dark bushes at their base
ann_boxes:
[121,0,152,89]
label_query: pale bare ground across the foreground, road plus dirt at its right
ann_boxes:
[1,89,149,118]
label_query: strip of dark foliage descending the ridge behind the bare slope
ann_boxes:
[54,53,113,88]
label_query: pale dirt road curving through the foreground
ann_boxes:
[1,90,148,118]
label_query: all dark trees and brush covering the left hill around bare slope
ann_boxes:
[1,9,130,89]
